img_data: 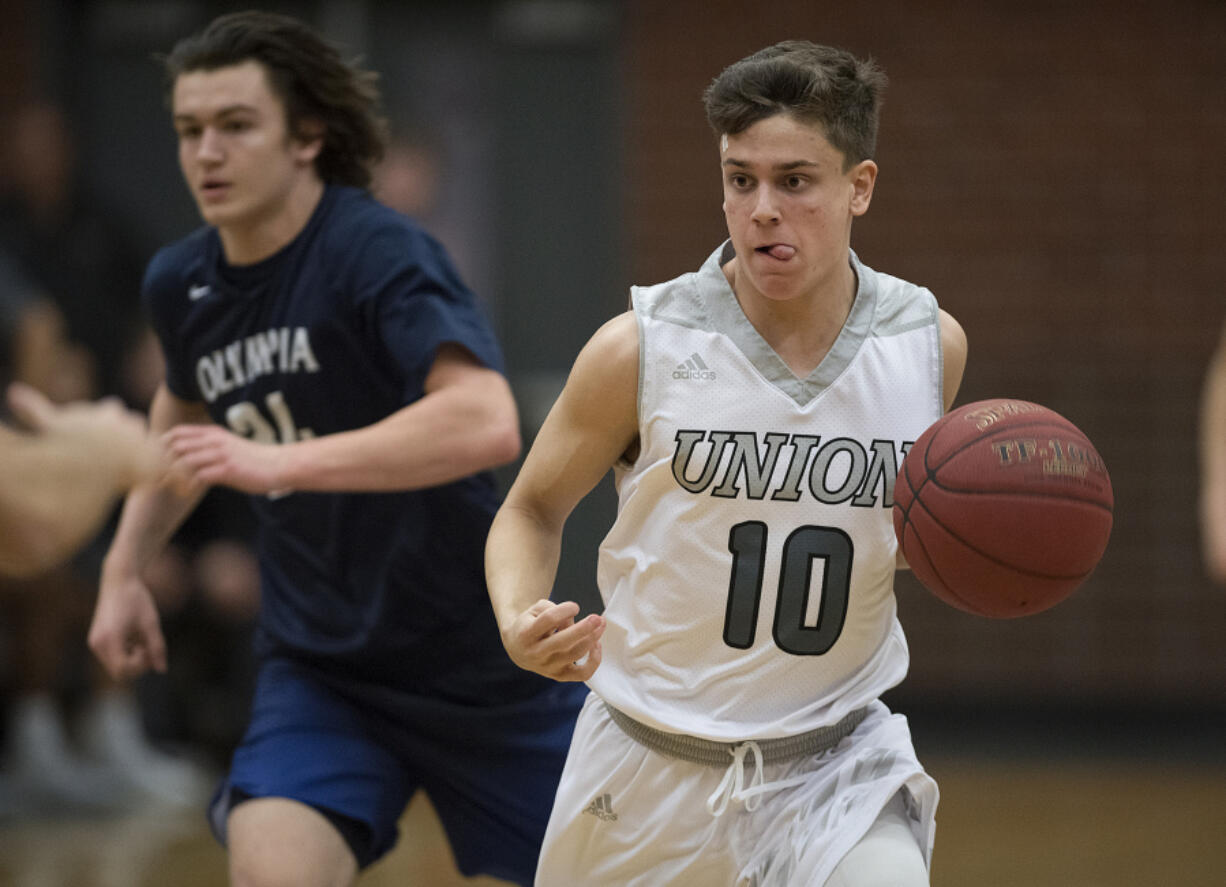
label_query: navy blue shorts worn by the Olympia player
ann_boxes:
[210,659,587,885]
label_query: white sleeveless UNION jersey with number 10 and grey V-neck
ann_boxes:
[588,244,943,741]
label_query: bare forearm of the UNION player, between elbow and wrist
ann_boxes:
[485,501,562,631]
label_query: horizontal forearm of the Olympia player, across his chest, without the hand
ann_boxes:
[278,375,520,492]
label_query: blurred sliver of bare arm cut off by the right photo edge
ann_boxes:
[1199,328,1226,584]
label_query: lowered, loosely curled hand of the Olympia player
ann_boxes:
[89,577,167,680]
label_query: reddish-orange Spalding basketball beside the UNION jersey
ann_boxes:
[894,399,1114,618]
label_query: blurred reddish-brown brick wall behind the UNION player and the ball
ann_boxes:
[624,0,1226,705]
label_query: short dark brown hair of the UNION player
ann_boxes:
[702,40,886,168]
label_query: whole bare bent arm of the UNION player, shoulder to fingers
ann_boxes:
[485,314,639,681]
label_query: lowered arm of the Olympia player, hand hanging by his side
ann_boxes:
[89,383,210,677]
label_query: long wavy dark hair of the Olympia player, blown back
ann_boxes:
[162,10,387,188]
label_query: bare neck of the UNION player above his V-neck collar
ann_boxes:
[726,252,857,379]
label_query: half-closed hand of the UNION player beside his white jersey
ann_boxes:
[503,600,606,681]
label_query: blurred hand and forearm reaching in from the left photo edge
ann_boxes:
[0,384,162,575]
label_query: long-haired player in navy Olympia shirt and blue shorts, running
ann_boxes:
[89,12,577,886]
